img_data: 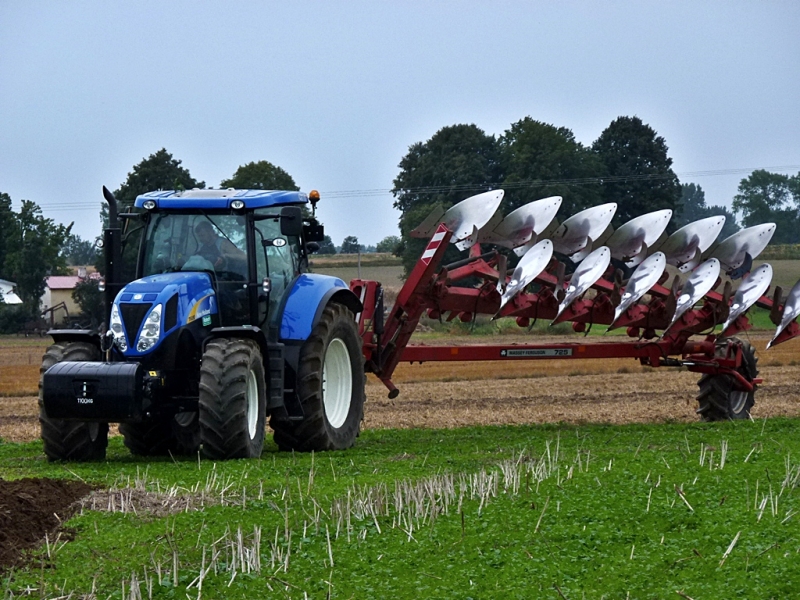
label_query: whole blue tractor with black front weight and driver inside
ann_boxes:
[39,188,364,461]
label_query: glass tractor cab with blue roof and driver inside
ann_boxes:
[131,190,308,331]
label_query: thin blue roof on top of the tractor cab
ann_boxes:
[134,188,308,209]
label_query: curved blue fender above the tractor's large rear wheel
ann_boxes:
[280,273,363,342]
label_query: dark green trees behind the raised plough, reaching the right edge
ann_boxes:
[392,116,800,270]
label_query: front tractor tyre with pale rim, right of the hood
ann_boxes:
[199,339,267,460]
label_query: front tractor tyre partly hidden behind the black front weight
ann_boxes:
[39,342,108,461]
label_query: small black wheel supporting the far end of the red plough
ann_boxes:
[697,338,758,421]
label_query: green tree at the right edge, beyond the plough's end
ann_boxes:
[733,169,800,244]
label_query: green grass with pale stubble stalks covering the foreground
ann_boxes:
[0,419,800,598]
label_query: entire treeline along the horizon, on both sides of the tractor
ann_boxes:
[0,132,800,327]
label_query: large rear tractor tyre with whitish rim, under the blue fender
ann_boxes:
[270,304,365,452]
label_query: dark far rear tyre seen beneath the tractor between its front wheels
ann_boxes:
[119,412,200,456]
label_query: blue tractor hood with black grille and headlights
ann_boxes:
[111,272,219,358]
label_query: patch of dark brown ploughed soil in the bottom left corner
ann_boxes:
[0,479,92,573]
